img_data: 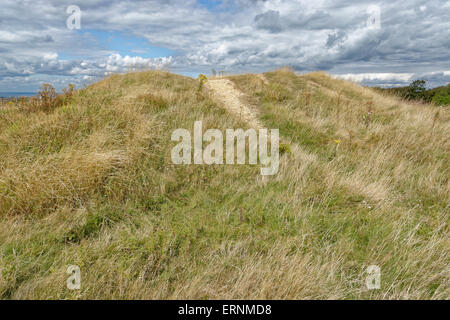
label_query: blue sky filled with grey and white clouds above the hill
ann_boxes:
[0,0,450,92]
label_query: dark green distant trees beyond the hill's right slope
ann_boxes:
[375,80,450,106]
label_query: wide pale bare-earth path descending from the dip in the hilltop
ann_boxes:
[205,78,263,128]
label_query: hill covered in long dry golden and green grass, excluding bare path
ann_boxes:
[0,70,450,299]
